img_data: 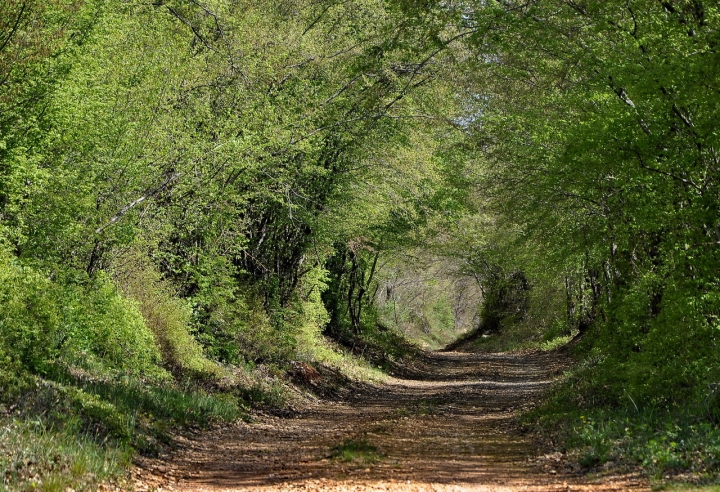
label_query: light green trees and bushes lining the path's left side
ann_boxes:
[0,0,464,490]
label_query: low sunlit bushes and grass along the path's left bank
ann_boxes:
[0,254,404,491]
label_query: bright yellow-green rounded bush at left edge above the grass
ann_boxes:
[0,251,162,377]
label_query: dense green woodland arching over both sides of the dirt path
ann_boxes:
[0,0,720,490]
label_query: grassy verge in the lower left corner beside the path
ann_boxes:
[0,371,256,491]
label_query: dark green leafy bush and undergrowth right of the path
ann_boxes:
[532,277,720,482]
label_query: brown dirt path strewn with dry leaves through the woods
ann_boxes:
[136,353,647,491]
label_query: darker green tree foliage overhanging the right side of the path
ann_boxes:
[444,1,720,426]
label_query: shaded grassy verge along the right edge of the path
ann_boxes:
[525,365,720,490]
